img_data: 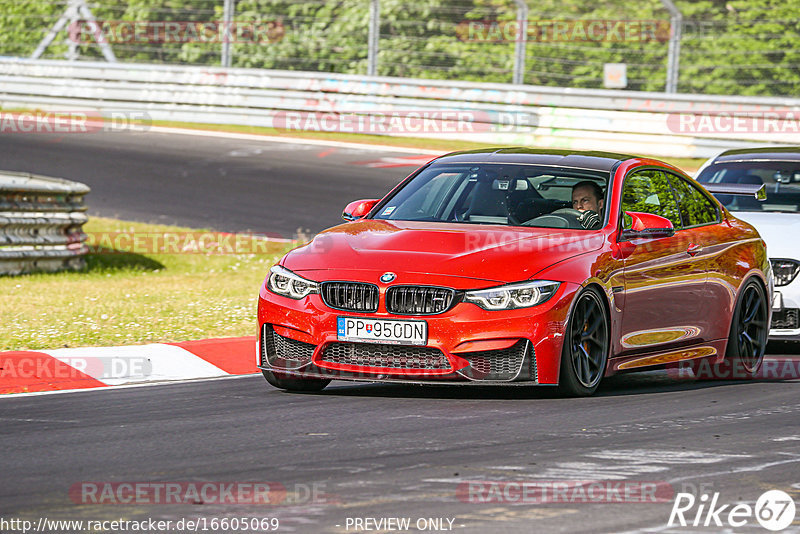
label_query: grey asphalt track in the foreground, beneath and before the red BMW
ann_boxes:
[0,373,800,533]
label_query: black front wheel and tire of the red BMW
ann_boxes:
[558,288,611,397]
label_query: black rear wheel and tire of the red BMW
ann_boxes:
[719,278,769,378]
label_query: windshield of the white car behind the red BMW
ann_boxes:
[697,161,800,212]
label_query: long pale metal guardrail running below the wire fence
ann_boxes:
[0,58,800,157]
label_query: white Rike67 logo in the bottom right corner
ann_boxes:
[667,490,795,532]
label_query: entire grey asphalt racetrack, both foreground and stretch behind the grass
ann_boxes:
[0,134,800,533]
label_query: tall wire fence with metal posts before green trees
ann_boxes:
[0,0,800,96]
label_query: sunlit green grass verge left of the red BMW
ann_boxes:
[0,217,288,350]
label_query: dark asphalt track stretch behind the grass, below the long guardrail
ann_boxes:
[0,132,413,238]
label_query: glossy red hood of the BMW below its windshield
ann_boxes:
[283,219,604,283]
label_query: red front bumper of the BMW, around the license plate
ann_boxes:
[257,283,579,385]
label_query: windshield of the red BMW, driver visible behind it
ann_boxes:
[375,163,609,230]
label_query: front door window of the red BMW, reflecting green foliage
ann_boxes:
[622,169,681,228]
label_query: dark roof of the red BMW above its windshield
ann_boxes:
[434,147,636,171]
